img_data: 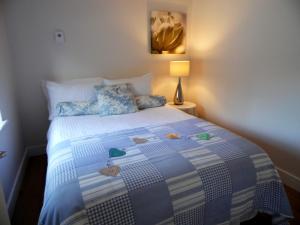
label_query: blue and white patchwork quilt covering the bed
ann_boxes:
[39,119,292,225]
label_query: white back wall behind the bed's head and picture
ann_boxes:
[6,0,190,146]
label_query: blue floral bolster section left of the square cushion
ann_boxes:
[56,101,99,116]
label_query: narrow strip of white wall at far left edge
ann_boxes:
[0,1,24,211]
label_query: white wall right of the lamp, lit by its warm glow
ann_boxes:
[189,0,300,185]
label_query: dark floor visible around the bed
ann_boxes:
[12,155,300,225]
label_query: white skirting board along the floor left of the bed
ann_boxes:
[7,145,46,218]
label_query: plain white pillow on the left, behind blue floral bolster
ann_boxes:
[42,78,103,120]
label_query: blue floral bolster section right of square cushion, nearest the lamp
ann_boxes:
[135,95,167,109]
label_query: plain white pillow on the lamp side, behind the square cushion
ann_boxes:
[104,73,152,95]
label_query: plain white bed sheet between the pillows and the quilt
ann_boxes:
[47,106,193,148]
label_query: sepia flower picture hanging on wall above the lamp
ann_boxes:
[150,11,186,54]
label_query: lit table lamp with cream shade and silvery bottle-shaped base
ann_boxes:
[170,61,190,105]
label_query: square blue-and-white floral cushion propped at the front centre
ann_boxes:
[95,84,138,116]
